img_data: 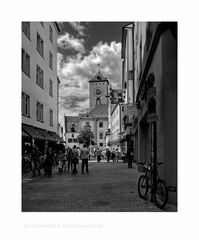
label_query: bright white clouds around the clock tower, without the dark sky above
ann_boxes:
[57,30,121,123]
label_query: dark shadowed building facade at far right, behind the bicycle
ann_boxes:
[136,22,177,203]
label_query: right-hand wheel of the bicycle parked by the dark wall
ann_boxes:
[154,179,168,209]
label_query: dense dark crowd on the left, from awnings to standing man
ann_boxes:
[22,145,90,177]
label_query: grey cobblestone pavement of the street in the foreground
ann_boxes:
[22,161,176,212]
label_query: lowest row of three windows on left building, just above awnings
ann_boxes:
[21,92,53,126]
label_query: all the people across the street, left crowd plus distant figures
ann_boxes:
[22,145,133,177]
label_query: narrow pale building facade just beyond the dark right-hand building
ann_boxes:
[121,23,138,157]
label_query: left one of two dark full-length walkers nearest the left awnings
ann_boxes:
[31,145,41,177]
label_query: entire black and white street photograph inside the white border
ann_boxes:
[21,21,178,212]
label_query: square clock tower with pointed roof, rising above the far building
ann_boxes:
[89,70,109,111]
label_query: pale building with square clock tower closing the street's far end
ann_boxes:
[65,71,109,148]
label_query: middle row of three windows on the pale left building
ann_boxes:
[22,49,53,97]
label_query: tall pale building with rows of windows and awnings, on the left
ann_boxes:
[21,22,63,154]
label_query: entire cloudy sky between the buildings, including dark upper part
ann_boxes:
[57,22,130,124]
